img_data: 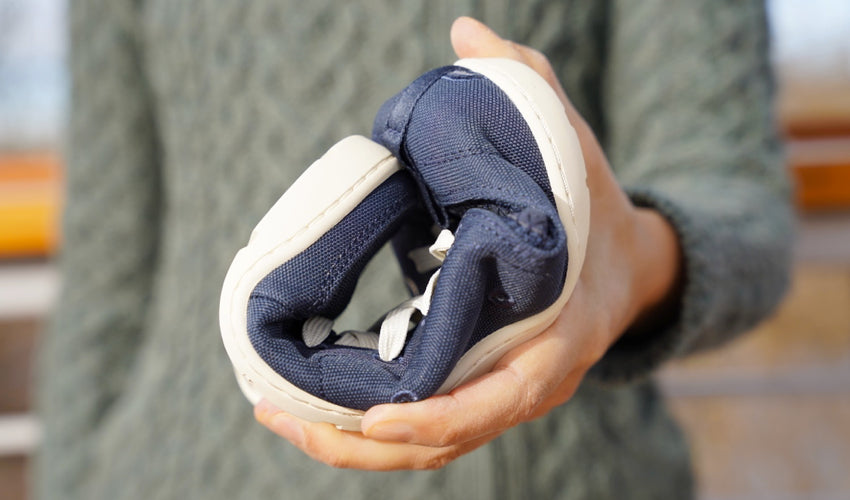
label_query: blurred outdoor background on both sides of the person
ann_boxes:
[0,0,850,500]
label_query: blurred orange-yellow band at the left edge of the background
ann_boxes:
[0,152,62,258]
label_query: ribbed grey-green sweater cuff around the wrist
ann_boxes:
[588,188,712,383]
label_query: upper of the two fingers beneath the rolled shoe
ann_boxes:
[361,283,610,447]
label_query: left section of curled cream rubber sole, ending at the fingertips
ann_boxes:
[219,136,400,430]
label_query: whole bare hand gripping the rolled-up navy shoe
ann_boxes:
[255,14,681,470]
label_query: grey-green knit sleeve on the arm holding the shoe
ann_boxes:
[591,0,792,382]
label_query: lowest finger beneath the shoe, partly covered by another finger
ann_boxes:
[254,400,498,470]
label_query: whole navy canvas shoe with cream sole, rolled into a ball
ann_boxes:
[220,59,589,430]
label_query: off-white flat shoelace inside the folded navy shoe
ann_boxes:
[301,229,455,361]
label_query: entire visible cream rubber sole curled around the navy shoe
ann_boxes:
[219,59,590,430]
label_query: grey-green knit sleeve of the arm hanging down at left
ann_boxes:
[37,0,160,496]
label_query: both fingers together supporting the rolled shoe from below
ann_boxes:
[254,324,580,470]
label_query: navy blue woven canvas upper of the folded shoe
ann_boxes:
[248,66,568,410]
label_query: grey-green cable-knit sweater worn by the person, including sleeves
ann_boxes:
[36,0,790,500]
